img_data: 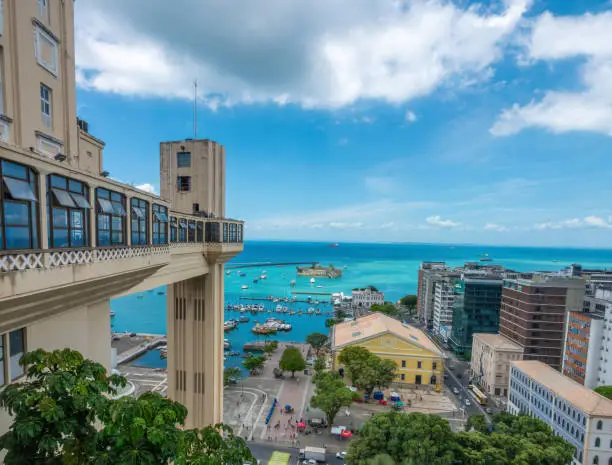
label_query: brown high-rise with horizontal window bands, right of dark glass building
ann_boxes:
[499,274,585,370]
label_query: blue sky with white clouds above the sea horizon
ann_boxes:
[75,0,612,248]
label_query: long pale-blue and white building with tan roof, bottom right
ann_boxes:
[507,360,612,465]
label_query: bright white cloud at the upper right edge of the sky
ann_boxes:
[491,11,612,136]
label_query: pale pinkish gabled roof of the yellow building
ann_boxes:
[333,312,442,355]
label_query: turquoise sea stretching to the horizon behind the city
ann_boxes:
[111,241,612,372]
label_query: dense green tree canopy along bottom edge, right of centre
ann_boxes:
[346,412,573,465]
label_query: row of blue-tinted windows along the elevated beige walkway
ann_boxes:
[0,160,243,250]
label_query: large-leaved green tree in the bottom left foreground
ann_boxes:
[0,349,253,465]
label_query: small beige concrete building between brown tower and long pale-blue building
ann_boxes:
[470,333,523,397]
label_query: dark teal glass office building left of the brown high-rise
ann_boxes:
[449,276,502,355]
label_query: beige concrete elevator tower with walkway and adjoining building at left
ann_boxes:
[0,0,243,433]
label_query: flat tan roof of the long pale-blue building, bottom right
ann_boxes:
[512,360,612,417]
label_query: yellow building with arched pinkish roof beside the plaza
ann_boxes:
[332,313,444,386]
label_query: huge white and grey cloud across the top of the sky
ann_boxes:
[75,0,530,108]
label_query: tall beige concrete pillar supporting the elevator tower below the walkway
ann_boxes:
[166,264,223,428]
